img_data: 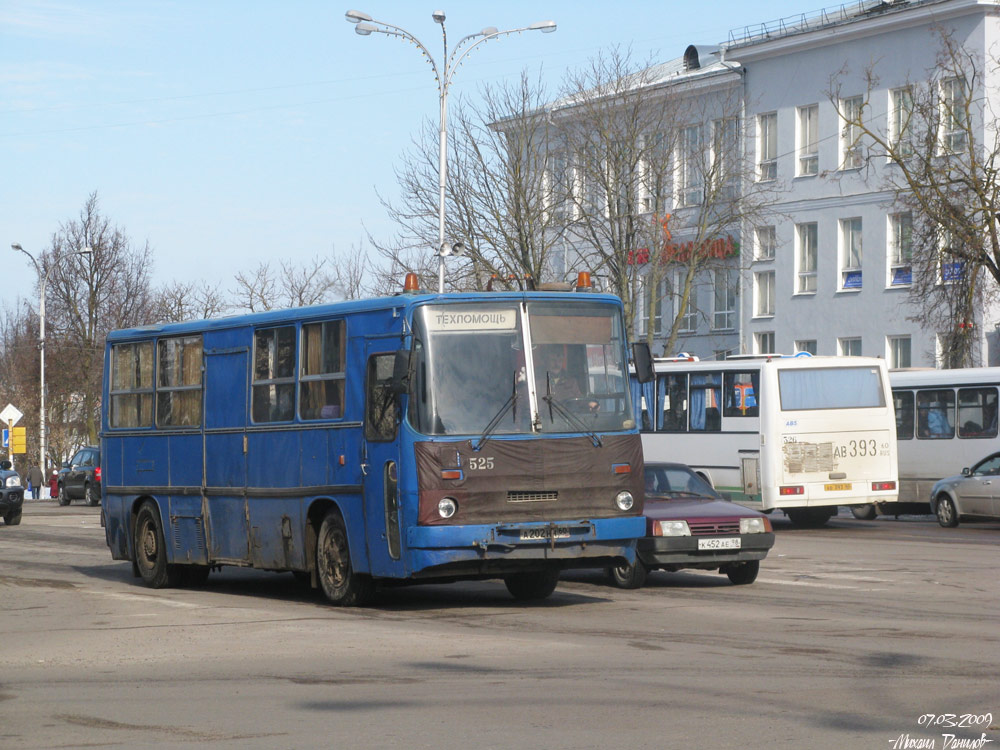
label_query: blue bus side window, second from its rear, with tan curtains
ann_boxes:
[156,336,202,427]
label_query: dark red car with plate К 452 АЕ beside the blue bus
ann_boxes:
[610,463,774,589]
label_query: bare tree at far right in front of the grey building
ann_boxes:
[830,28,1000,367]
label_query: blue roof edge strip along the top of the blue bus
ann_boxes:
[108,291,622,342]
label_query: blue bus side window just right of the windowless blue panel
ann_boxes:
[251,326,295,423]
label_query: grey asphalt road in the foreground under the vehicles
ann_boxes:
[0,501,1000,750]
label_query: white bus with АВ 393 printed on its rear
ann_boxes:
[632,355,897,526]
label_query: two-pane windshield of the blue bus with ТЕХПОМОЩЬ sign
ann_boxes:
[409,300,634,435]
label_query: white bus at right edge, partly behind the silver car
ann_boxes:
[870,367,1000,517]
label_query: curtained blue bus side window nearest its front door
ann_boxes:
[299,320,347,419]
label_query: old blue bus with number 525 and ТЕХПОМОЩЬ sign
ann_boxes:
[101,284,645,606]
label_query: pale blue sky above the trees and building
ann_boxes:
[0,0,812,306]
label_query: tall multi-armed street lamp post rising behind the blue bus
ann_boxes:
[345,10,556,293]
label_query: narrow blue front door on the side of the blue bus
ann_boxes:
[362,352,406,577]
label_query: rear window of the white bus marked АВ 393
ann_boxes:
[778,367,885,411]
